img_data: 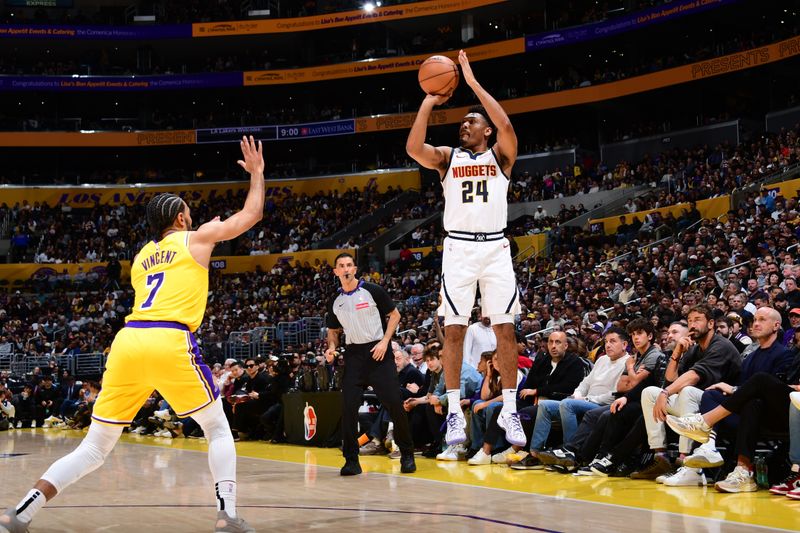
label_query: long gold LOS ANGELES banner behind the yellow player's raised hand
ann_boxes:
[0,169,420,207]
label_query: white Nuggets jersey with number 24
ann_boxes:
[442,148,509,233]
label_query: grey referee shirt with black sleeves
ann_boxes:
[325,281,395,344]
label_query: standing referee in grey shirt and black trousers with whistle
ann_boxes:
[325,252,417,476]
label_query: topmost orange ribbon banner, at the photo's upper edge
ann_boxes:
[192,0,505,37]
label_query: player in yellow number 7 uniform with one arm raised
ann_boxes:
[0,137,264,533]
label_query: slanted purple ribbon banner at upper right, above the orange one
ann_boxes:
[525,0,738,52]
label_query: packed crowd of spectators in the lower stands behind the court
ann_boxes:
[0,161,800,497]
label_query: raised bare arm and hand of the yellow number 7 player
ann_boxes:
[192,136,264,248]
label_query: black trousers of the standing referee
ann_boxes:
[342,342,414,460]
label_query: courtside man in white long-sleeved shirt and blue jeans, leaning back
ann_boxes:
[526,326,630,469]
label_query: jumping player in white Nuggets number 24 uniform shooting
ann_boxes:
[406,50,525,446]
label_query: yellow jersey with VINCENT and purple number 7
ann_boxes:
[127,231,208,331]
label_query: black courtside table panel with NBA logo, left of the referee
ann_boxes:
[281,391,342,448]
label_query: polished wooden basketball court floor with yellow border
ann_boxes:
[0,429,800,533]
